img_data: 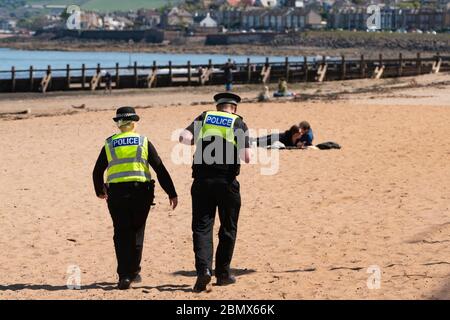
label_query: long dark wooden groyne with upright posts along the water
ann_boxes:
[0,53,450,93]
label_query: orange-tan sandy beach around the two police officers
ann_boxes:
[0,74,450,299]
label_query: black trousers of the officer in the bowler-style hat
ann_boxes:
[108,182,154,279]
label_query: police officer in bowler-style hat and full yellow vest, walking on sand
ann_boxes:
[93,107,178,290]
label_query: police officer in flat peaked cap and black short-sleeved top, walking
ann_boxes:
[180,93,250,292]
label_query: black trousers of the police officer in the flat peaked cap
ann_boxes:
[191,179,241,277]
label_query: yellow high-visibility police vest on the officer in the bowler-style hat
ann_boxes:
[105,132,151,183]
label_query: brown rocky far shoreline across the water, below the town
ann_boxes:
[0,37,442,59]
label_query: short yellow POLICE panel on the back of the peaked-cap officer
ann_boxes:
[199,111,239,145]
